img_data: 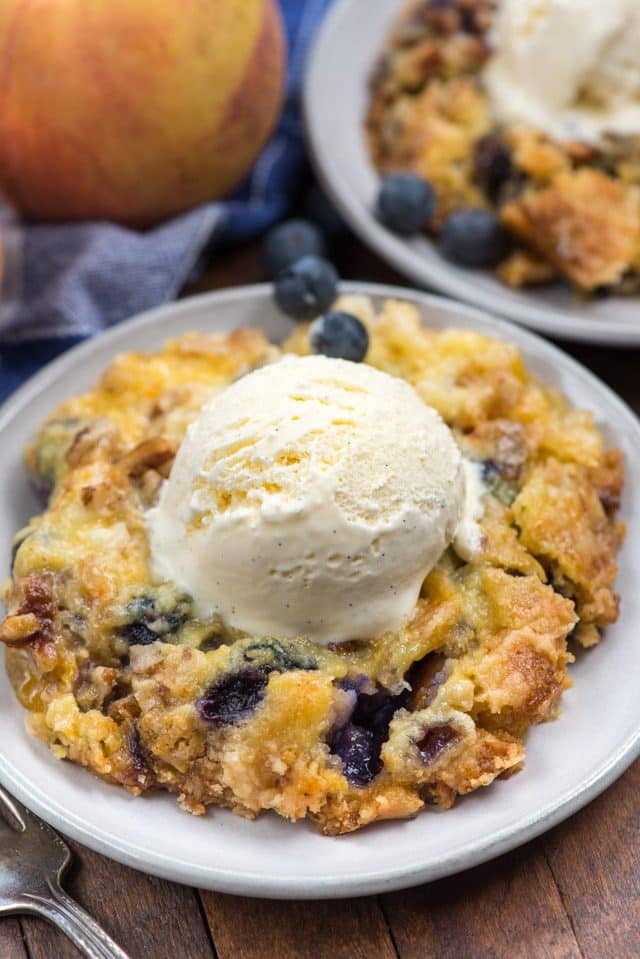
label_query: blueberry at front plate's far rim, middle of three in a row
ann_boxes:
[275,256,338,320]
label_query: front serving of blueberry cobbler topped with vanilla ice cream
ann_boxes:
[0,296,623,835]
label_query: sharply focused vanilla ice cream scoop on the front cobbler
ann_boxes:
[149,356,480,643]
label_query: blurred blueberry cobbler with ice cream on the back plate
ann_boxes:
[367,0,640,296]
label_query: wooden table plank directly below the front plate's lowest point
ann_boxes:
[201,892,397,959]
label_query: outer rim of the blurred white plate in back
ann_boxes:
[302,0,640,348]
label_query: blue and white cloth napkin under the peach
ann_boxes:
[0,0,331,400]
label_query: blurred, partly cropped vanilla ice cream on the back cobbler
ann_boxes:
[484,0,640,144]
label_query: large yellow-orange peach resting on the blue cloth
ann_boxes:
[0,0,285,226]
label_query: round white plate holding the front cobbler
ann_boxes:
[0,284,640,898]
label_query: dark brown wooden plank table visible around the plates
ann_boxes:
[0,239,640,959]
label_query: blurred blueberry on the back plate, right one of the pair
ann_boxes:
[441,208,508,267]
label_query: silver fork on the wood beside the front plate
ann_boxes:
[0,786,129,959]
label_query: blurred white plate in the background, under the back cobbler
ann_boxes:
[304,0,640,346]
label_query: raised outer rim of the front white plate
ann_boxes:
[0,282,640,899]
